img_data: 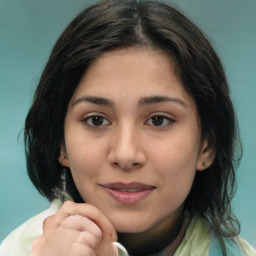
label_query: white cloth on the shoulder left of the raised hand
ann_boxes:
[0,200,61,256]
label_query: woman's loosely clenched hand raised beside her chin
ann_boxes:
[31,201,118,256]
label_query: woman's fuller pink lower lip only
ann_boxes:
[103,187,154,204]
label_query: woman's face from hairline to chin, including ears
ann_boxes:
[59,48,210,236]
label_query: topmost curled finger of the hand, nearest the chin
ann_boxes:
[60,201,117,242]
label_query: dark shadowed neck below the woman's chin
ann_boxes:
[118,211,187,255]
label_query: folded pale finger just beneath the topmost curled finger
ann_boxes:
[61,214,102,238]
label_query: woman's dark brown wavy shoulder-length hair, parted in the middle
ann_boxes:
[25,0,239,254]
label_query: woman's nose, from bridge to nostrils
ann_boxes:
[108,125,146,170]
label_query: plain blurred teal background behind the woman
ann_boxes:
[0,0,256,247]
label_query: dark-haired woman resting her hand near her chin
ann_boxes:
[1,1,255,256]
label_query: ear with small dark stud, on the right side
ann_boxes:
[196,137,215,171]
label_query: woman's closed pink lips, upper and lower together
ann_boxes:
[102,182,155,204]
